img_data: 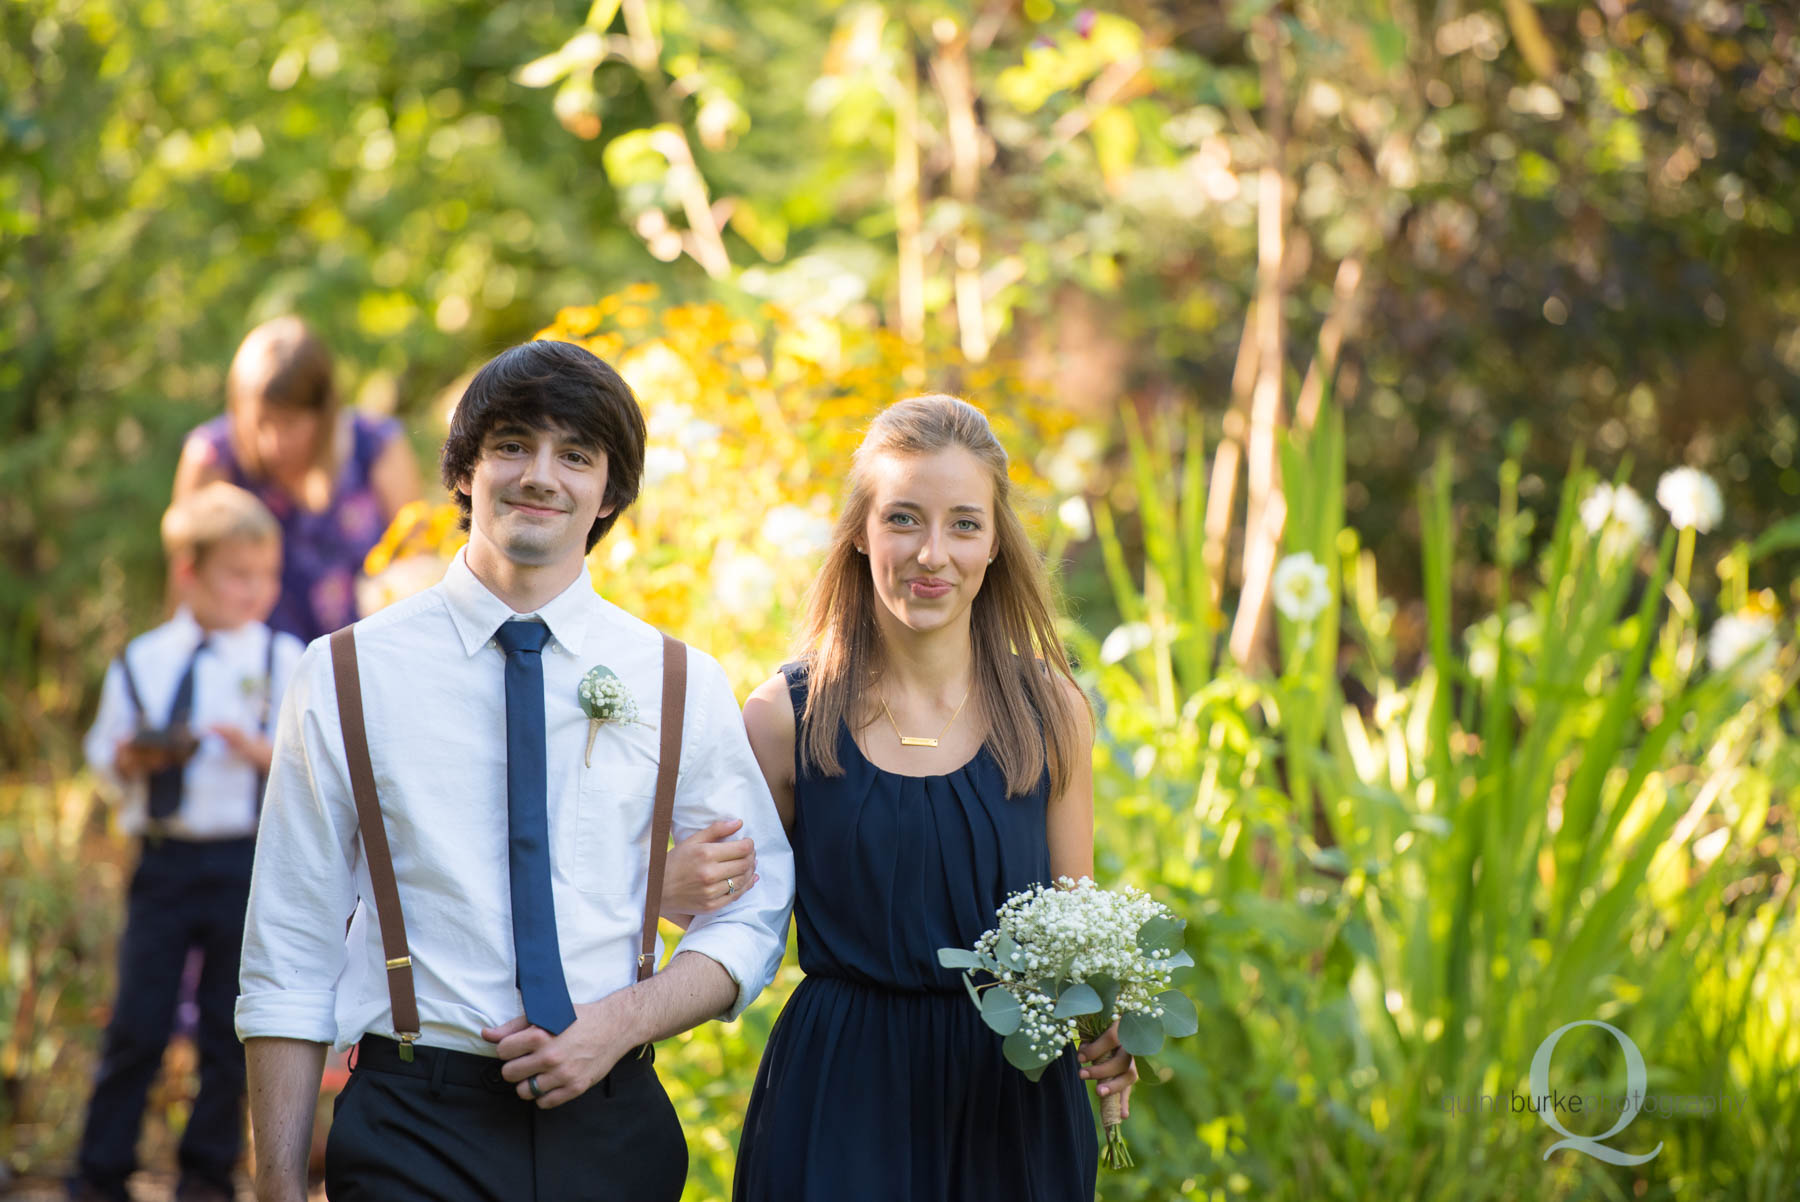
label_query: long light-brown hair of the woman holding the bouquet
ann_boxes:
[799,396,1085,797]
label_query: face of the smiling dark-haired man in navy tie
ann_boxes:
[457,425,612,567]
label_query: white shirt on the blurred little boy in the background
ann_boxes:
[83,608,302,840]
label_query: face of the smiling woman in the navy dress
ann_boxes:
[857,446,995,633]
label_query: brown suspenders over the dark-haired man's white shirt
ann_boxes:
[331,626,688,1060]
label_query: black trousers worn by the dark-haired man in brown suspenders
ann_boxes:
[326,1035,688,1202]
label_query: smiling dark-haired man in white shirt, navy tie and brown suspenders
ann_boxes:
[238,342,794,1202]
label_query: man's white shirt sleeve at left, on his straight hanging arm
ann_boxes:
[236,639,360,1044]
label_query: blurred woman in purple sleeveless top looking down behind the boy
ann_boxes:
[175,317,419,642]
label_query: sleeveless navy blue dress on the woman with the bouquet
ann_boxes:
[733,664,1098,1202]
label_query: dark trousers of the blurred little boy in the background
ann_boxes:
[77,839,256,1197]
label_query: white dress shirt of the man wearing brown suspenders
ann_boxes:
[238,552,794,1056]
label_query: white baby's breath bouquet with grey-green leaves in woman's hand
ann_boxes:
[938,876,1199,1168]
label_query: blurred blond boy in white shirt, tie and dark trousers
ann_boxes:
[70,484,302,1202]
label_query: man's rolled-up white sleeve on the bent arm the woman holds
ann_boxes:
[673,653,794,1022]
